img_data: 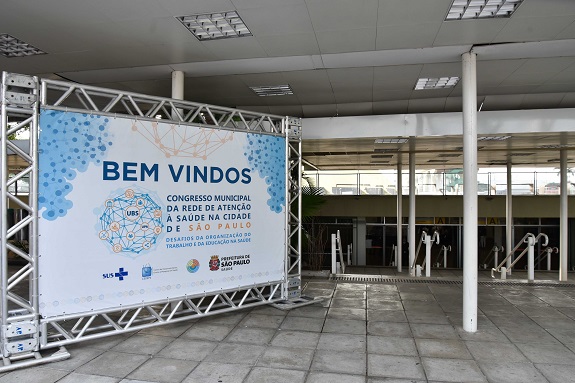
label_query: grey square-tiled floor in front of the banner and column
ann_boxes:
[0,271,575,383]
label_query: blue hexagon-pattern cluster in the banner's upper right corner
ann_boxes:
[244,134,286,213]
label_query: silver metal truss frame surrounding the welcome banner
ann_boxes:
[0,72,302,372]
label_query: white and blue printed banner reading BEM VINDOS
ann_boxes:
[38,110,286,317]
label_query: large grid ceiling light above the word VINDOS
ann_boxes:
[176,11,252,41]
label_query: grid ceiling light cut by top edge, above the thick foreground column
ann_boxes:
[445,0,523,21]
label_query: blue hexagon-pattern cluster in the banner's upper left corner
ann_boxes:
[38,110,112,221]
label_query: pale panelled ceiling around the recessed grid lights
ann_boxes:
[0,0,575,169]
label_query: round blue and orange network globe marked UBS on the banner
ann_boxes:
[98,189,164,255]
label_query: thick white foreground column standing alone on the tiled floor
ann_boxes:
[462,52,478,332]
